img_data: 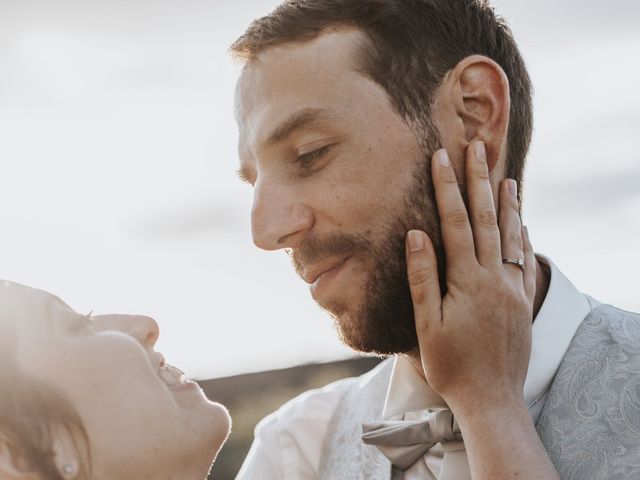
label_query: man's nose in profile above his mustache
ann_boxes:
[251,178,314,250]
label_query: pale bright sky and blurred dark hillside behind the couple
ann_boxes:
[0,0,640,479]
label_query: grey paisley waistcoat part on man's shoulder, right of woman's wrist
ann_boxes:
[537,305,640,480]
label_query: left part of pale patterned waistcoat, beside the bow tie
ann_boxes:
[319,359,393,480]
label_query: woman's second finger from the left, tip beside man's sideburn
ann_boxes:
[431,149,478,272]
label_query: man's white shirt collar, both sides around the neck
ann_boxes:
[382,255,590,420]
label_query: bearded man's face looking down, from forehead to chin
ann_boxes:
[236,30,440,353]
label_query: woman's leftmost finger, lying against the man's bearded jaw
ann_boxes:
[406,230,442,340]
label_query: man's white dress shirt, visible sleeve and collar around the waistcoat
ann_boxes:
[236,255,598,480]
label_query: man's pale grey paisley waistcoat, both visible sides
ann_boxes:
[319,305,640,480]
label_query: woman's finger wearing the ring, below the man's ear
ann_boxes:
[500,178,525,283]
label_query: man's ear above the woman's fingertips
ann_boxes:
[438,55,511,171]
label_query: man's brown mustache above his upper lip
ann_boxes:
[287,233,371,275]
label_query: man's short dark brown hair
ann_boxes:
[231,0,533,195]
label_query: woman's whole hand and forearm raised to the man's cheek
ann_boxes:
[407,142,558,480]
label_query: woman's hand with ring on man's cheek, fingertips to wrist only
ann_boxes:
[407,143,536,408]
